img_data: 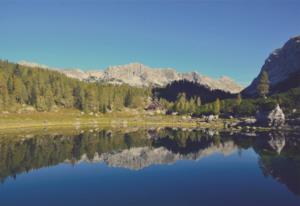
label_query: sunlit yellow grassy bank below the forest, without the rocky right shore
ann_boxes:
[0,110,227,130]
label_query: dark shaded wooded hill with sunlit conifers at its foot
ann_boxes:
[153,80,241,115]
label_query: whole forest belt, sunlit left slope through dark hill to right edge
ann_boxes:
[0,61,300,116]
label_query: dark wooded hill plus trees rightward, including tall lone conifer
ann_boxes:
[154,72,300,117]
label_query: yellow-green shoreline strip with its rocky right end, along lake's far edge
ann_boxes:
[0,111,297,132]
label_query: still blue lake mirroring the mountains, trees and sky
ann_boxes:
[0,128,300,206]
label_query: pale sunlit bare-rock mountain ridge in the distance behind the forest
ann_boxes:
[20,61,243,93]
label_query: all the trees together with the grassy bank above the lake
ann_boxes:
[0,58,300,129]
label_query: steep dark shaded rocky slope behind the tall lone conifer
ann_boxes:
[243,36,300,95]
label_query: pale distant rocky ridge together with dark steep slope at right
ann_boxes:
[19,36,300,96]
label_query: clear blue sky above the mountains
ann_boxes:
[0,0,300,85]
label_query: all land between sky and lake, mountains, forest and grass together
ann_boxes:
[0,37,300,132]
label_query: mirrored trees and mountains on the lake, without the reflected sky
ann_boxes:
[0,128,300,195]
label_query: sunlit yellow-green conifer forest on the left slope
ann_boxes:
[0,61,151,113]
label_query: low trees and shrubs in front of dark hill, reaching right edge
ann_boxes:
[160,88,300,117]
